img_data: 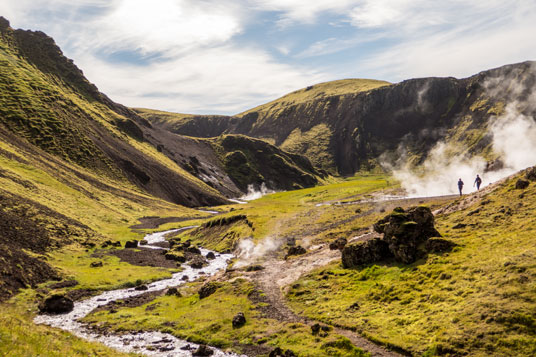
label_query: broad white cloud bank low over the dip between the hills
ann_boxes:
[78,45,327,114]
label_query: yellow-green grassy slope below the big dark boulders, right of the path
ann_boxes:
[288,174,536,356]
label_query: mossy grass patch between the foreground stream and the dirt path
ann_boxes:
[84,279,365,356]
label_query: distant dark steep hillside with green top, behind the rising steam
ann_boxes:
[140,62,536,175]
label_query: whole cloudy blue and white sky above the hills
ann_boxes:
[0,0,536,114]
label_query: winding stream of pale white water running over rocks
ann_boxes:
[34,227,242,356]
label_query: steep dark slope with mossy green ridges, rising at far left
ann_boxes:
[0,19,225,206]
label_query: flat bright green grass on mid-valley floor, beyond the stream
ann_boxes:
[178,175,397,251]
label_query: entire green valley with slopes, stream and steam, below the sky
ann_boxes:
[0,17,536,357]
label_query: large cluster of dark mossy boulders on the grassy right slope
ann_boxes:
[342,206,448,268]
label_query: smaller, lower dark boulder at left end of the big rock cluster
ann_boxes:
[342,237,393,268]
